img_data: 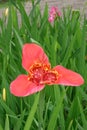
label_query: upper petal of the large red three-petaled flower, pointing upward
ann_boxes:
[22,43,49,71]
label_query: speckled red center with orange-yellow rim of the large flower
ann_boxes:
[28,63,59,85]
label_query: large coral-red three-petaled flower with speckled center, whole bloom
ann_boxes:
[10,43,84,96]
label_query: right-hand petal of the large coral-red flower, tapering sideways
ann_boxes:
[54,65,84,86]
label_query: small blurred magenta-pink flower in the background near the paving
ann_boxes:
[48,6,61,22]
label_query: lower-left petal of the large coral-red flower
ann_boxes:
[10,75,44,97]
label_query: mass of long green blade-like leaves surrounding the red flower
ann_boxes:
[0,0,87,130]
